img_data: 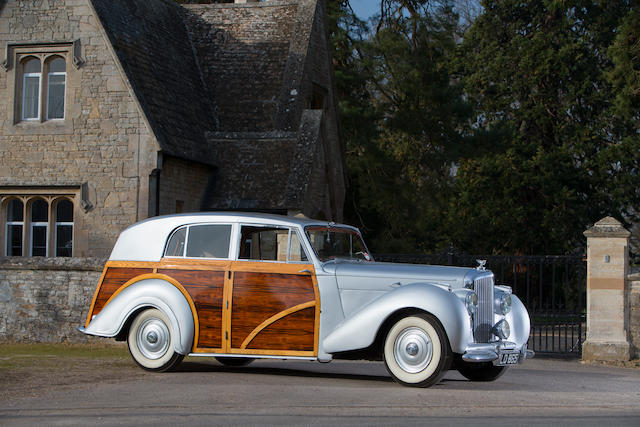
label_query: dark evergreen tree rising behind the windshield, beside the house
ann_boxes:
[332,0,469,252]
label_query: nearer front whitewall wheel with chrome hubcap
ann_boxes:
[384,313,452,387]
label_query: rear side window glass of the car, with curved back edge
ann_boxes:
[165,224,231,259]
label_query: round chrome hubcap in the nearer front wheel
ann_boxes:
[394,327,433,374]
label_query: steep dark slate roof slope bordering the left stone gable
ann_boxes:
[91,0,216,164]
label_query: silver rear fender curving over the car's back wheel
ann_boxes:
[81,279,195,354]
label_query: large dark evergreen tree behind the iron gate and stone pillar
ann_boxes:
[450,0,640,254]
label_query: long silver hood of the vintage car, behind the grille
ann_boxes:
[324,262,487,290]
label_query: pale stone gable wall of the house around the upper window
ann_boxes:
[0,0,158,256]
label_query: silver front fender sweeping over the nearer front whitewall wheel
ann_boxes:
[323,283,473,353]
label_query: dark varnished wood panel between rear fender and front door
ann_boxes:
[158,269,225,348]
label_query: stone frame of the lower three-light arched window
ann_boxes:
[0,187,81,257]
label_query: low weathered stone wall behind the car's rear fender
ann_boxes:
[0,257,105,342]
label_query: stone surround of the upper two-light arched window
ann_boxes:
[0,39,84,135]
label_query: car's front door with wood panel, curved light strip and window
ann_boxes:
[227,224,320,357]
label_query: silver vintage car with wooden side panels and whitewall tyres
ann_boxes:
[80,213,533,387]
